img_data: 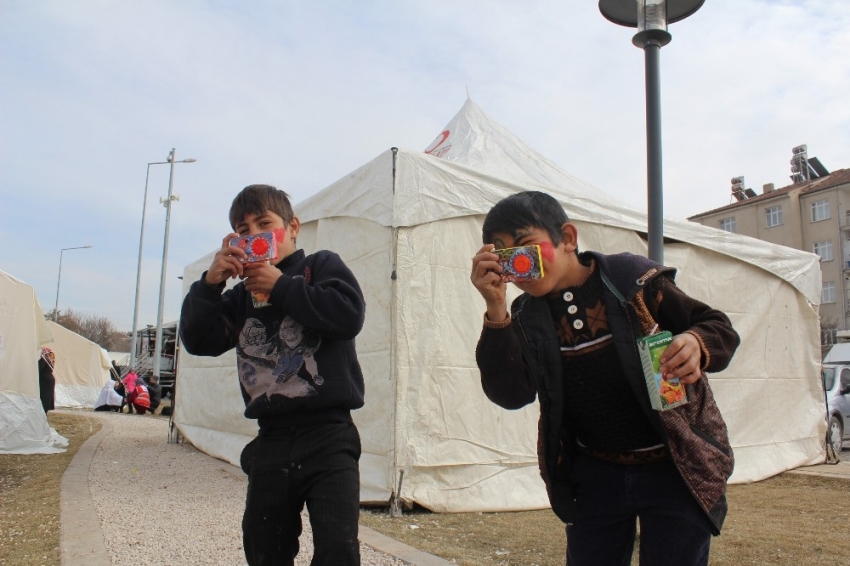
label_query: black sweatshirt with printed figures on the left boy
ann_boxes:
[180,250,366,428]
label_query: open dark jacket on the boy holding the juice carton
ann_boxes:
[476,252,740,534]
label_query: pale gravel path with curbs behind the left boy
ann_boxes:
[60,411,450,566]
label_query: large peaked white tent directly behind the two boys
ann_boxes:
[176,101,825,512]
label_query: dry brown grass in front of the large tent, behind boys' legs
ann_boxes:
[360,474,850,566]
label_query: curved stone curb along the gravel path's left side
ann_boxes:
[59,417,112,566]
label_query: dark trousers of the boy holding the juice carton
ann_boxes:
[567,455,711,566]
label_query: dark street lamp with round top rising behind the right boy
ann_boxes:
[599,0,705,263]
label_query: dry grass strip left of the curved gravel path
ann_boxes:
[0,412,100,566]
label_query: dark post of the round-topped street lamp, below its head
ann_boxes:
[643,41,664,263]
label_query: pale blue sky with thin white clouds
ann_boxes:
[0,0,850,336]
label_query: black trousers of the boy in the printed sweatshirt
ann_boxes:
[241,422,360,566]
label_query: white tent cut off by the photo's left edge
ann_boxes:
[0,271,62,454]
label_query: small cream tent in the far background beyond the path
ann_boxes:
[47,321,112,409]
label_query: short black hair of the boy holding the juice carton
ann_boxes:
[481,191,570,246]
